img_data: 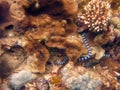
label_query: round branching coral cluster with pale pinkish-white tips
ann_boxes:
[78,0,111,32]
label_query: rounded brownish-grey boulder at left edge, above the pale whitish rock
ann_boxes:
[0,46,26,78]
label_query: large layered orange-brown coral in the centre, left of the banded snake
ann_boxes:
[25,14,86,62]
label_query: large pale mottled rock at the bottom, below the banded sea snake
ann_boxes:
[61,63,102,90]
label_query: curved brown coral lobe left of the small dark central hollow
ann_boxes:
[25,41,49,73]
